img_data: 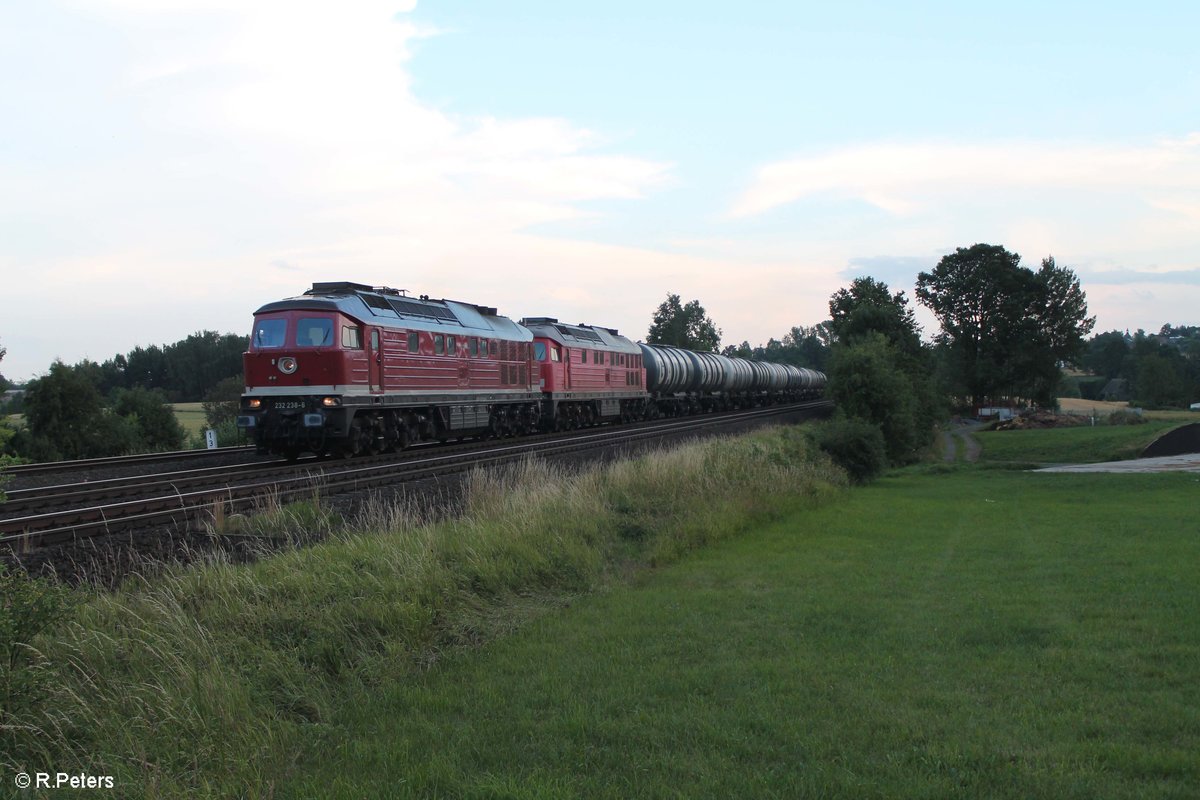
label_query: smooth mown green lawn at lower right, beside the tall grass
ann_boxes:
[278,468,1200,799]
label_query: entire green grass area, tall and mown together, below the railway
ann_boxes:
[9,425,1200,799]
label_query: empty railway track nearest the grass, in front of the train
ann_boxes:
[0,401,829,554]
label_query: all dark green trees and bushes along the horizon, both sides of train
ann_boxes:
[0,250,1200,476]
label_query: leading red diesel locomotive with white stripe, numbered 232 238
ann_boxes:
[238,283,541,457]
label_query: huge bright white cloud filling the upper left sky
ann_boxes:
[0,0,671,374]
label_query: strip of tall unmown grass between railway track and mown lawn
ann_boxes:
[0,428,846,796]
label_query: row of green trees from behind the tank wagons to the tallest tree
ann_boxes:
[648,243,1128,480]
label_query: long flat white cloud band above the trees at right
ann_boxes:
[730,133,1200,217]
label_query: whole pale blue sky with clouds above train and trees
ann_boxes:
[0,0,1200,380]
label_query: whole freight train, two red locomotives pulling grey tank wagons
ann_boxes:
[238,282,826,458]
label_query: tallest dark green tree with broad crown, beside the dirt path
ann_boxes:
[917,245,1096,404]
